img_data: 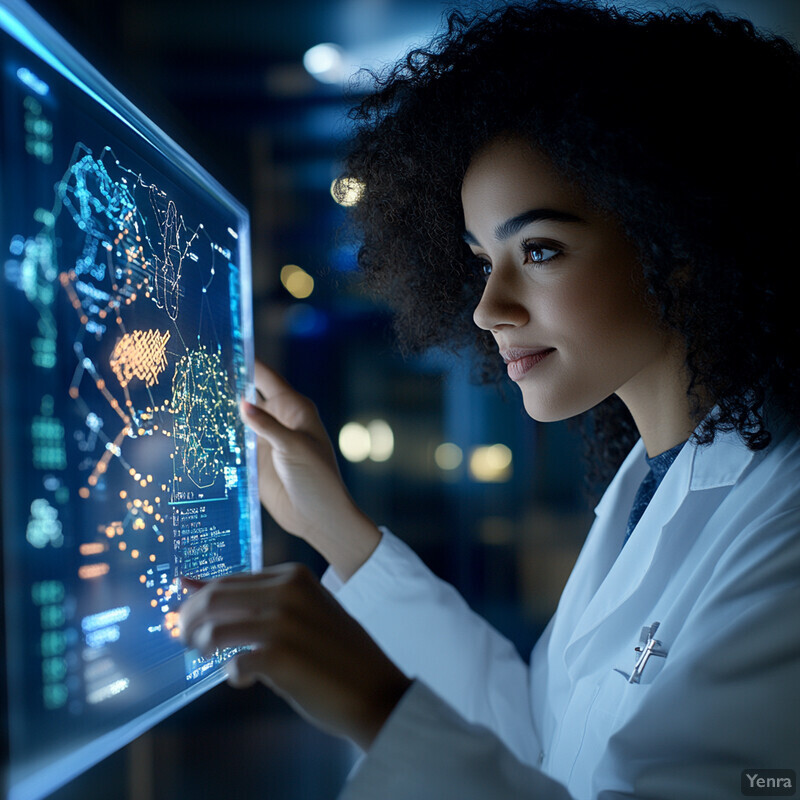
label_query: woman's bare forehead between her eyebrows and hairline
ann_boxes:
[461,139,587,229]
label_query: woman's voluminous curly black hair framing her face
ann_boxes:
[344,0,800,490]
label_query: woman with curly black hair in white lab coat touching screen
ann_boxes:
[182,0,800,800]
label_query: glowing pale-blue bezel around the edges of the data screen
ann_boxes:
[0,0,262,800]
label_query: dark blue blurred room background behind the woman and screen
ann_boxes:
[10,0,800,800]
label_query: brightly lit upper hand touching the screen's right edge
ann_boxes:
[241,361,381,581]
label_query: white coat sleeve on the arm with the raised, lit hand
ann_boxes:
[323,529,540,763]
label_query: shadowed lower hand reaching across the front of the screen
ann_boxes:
[180,564,411,750]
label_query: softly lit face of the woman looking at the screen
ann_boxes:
[461,139,682,422]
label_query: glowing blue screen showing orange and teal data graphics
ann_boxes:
[0,3,260,798]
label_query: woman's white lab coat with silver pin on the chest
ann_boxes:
[323,416,800,800]
